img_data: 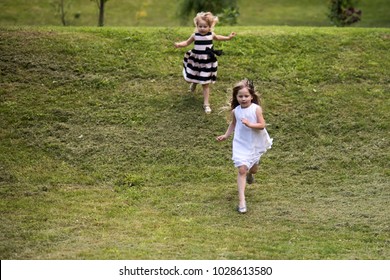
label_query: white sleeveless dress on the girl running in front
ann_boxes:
[232,103,272,169]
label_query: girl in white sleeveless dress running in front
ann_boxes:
[217,79,272,213]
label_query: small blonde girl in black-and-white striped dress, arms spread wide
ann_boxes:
[175,12,236,114]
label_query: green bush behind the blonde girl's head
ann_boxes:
[178,0,239,24]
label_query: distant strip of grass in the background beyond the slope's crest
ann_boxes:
[0,0,390,27]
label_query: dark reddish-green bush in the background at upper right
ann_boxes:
[328,0,362,26]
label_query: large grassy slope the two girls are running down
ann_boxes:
[0,27,390,259]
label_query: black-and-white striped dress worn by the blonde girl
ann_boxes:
[183,32,218,84]
